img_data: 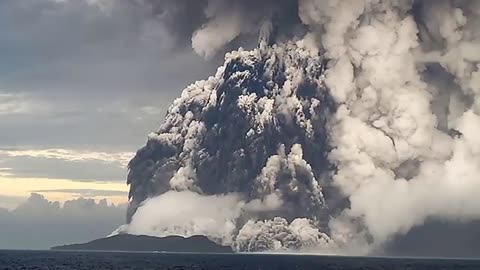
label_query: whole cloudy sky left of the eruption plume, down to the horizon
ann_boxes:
[0,0,215,249]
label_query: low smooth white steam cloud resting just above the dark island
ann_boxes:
[120,191,243,244]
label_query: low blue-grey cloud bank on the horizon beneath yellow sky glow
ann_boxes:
[0,193,125,249]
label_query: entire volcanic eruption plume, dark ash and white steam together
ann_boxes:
[115,0,480,254]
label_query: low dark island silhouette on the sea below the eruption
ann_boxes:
[51,234,233,253]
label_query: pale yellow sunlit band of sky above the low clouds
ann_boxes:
[0,149,133,209]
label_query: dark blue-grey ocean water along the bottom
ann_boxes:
[0,251,480,270]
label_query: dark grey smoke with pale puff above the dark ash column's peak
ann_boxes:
[140,0,301,58]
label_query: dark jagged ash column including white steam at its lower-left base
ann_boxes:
[119,42,334,251]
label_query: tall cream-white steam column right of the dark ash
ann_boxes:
[300,0,480,248]
